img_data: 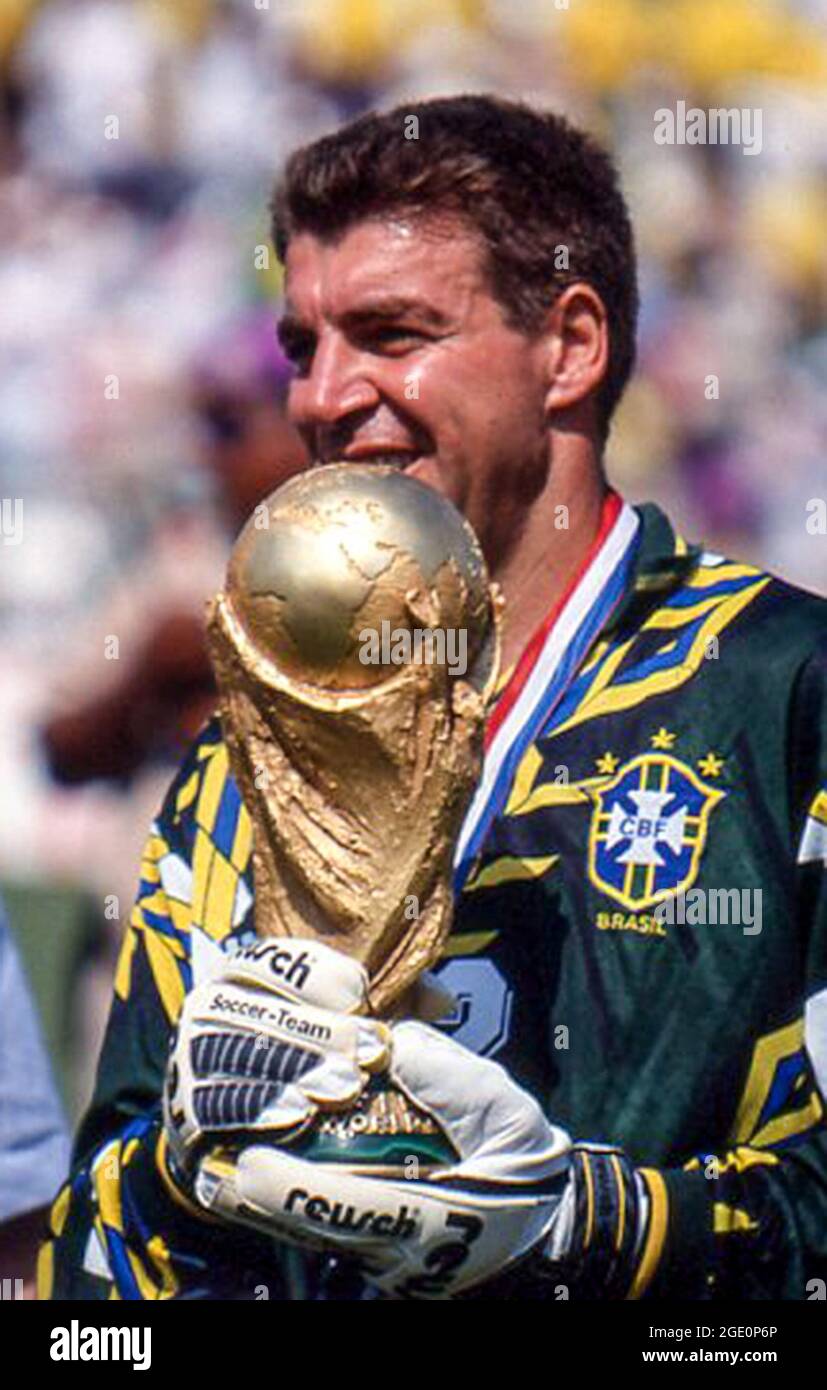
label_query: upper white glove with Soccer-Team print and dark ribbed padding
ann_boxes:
[164,938,391,1187]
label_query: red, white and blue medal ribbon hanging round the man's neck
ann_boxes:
[453,492,641,894]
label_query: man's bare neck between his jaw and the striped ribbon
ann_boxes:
[492,455,609,671]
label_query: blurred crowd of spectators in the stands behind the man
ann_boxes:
[0,0,827,1112]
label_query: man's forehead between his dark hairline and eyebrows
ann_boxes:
[285,215,491,320]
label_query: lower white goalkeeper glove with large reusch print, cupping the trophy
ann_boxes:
[196,1023,570,1298]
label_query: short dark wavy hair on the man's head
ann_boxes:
[271,96,638,434]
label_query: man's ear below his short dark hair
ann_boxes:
[542,284,609,413]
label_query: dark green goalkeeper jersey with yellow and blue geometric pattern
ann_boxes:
[39,506,827,1300]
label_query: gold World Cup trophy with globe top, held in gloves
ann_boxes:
[207,464,502,1172]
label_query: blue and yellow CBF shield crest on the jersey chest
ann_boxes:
[589,753,726,910]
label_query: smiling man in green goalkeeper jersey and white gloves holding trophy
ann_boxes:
[42,97,827,1298]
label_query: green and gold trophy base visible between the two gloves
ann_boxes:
[290,1079,457,1180]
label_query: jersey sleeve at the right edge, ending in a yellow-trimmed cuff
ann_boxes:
[637,649,827,1300]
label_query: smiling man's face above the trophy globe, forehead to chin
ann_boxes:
[279,218,548,562]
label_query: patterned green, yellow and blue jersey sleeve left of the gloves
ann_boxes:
[38,726,297,1300]
